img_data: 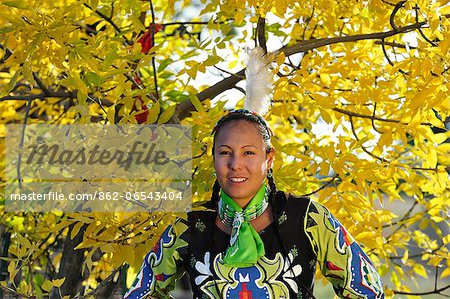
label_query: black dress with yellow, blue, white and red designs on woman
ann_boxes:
[125,191,384,299]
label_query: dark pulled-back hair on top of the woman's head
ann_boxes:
[212,109,273,156]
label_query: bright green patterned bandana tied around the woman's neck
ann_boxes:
[219,184,270,267]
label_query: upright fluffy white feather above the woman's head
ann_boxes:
[244,47,272,116]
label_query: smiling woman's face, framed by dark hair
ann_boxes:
[214,120,274,207]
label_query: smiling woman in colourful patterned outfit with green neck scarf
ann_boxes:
[125,110,384,299]
